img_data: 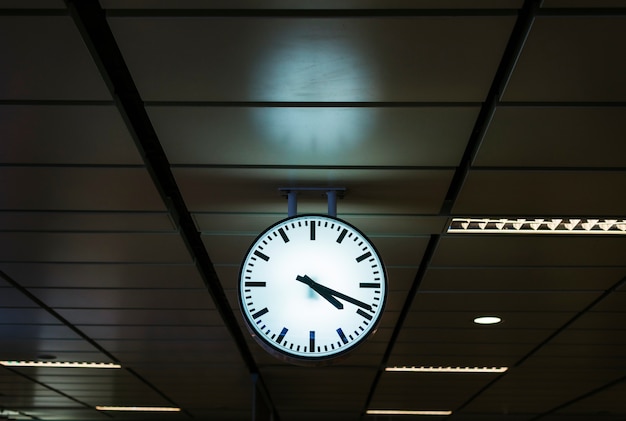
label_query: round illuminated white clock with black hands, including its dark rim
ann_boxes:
[239,215,387,364]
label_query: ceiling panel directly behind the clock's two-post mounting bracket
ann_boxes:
[173,167,452,214]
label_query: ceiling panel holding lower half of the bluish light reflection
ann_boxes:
[148,106,478,166]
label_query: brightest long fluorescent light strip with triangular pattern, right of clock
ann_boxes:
[448,218,626,235]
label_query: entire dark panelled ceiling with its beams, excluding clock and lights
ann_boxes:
[0,0,626,421]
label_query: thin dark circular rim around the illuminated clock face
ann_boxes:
[237,213,389,366]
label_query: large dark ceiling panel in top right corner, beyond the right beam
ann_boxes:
[502,16,626,102]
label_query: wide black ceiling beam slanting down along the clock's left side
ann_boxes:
[66,0,279,420]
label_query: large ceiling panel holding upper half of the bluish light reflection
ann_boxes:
[109,16,514,102]
